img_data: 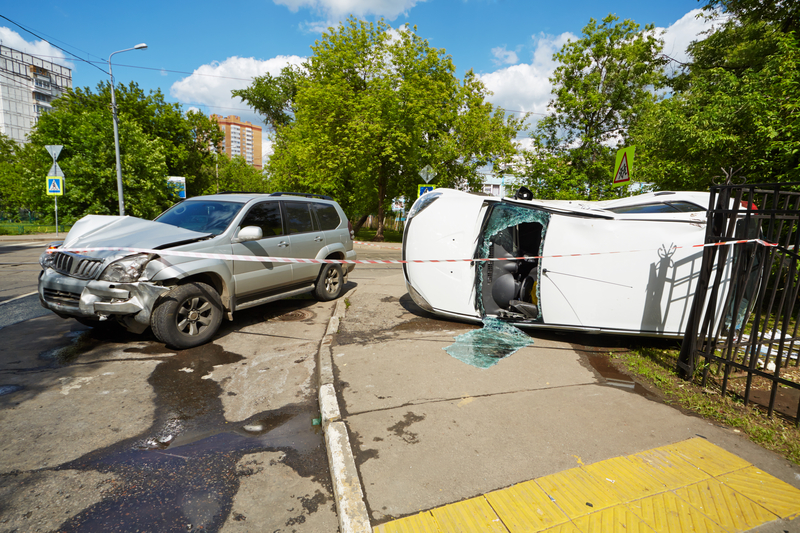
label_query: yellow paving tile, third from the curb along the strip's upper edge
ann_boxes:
[486,481,569,533]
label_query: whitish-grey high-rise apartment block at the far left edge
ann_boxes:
[0,45,72,143]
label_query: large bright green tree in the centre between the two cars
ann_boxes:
[235,18,521,240]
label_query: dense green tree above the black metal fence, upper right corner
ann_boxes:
[633,0,800,190]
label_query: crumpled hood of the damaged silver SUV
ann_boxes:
[62,215,211,249]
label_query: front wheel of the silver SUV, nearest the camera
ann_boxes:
[150,283,222,349]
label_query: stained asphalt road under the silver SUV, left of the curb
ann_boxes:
[0,242,400,532]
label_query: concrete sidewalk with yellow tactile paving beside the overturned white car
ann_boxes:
[331,269,800,531]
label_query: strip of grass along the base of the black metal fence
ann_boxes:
[610,347,800,465]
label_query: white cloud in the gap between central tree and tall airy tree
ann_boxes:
[480,33,576,120]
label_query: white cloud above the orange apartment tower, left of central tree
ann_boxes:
[169,55,304,124]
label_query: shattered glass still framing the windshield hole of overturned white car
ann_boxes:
[475,203,550,318]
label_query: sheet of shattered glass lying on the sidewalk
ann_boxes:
[443,317,533,368]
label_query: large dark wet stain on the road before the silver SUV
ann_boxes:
[57,344,331,532]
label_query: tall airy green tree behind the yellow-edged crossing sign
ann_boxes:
[521,15,664,200]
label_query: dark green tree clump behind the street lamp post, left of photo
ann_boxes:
[15,84,223,221]
